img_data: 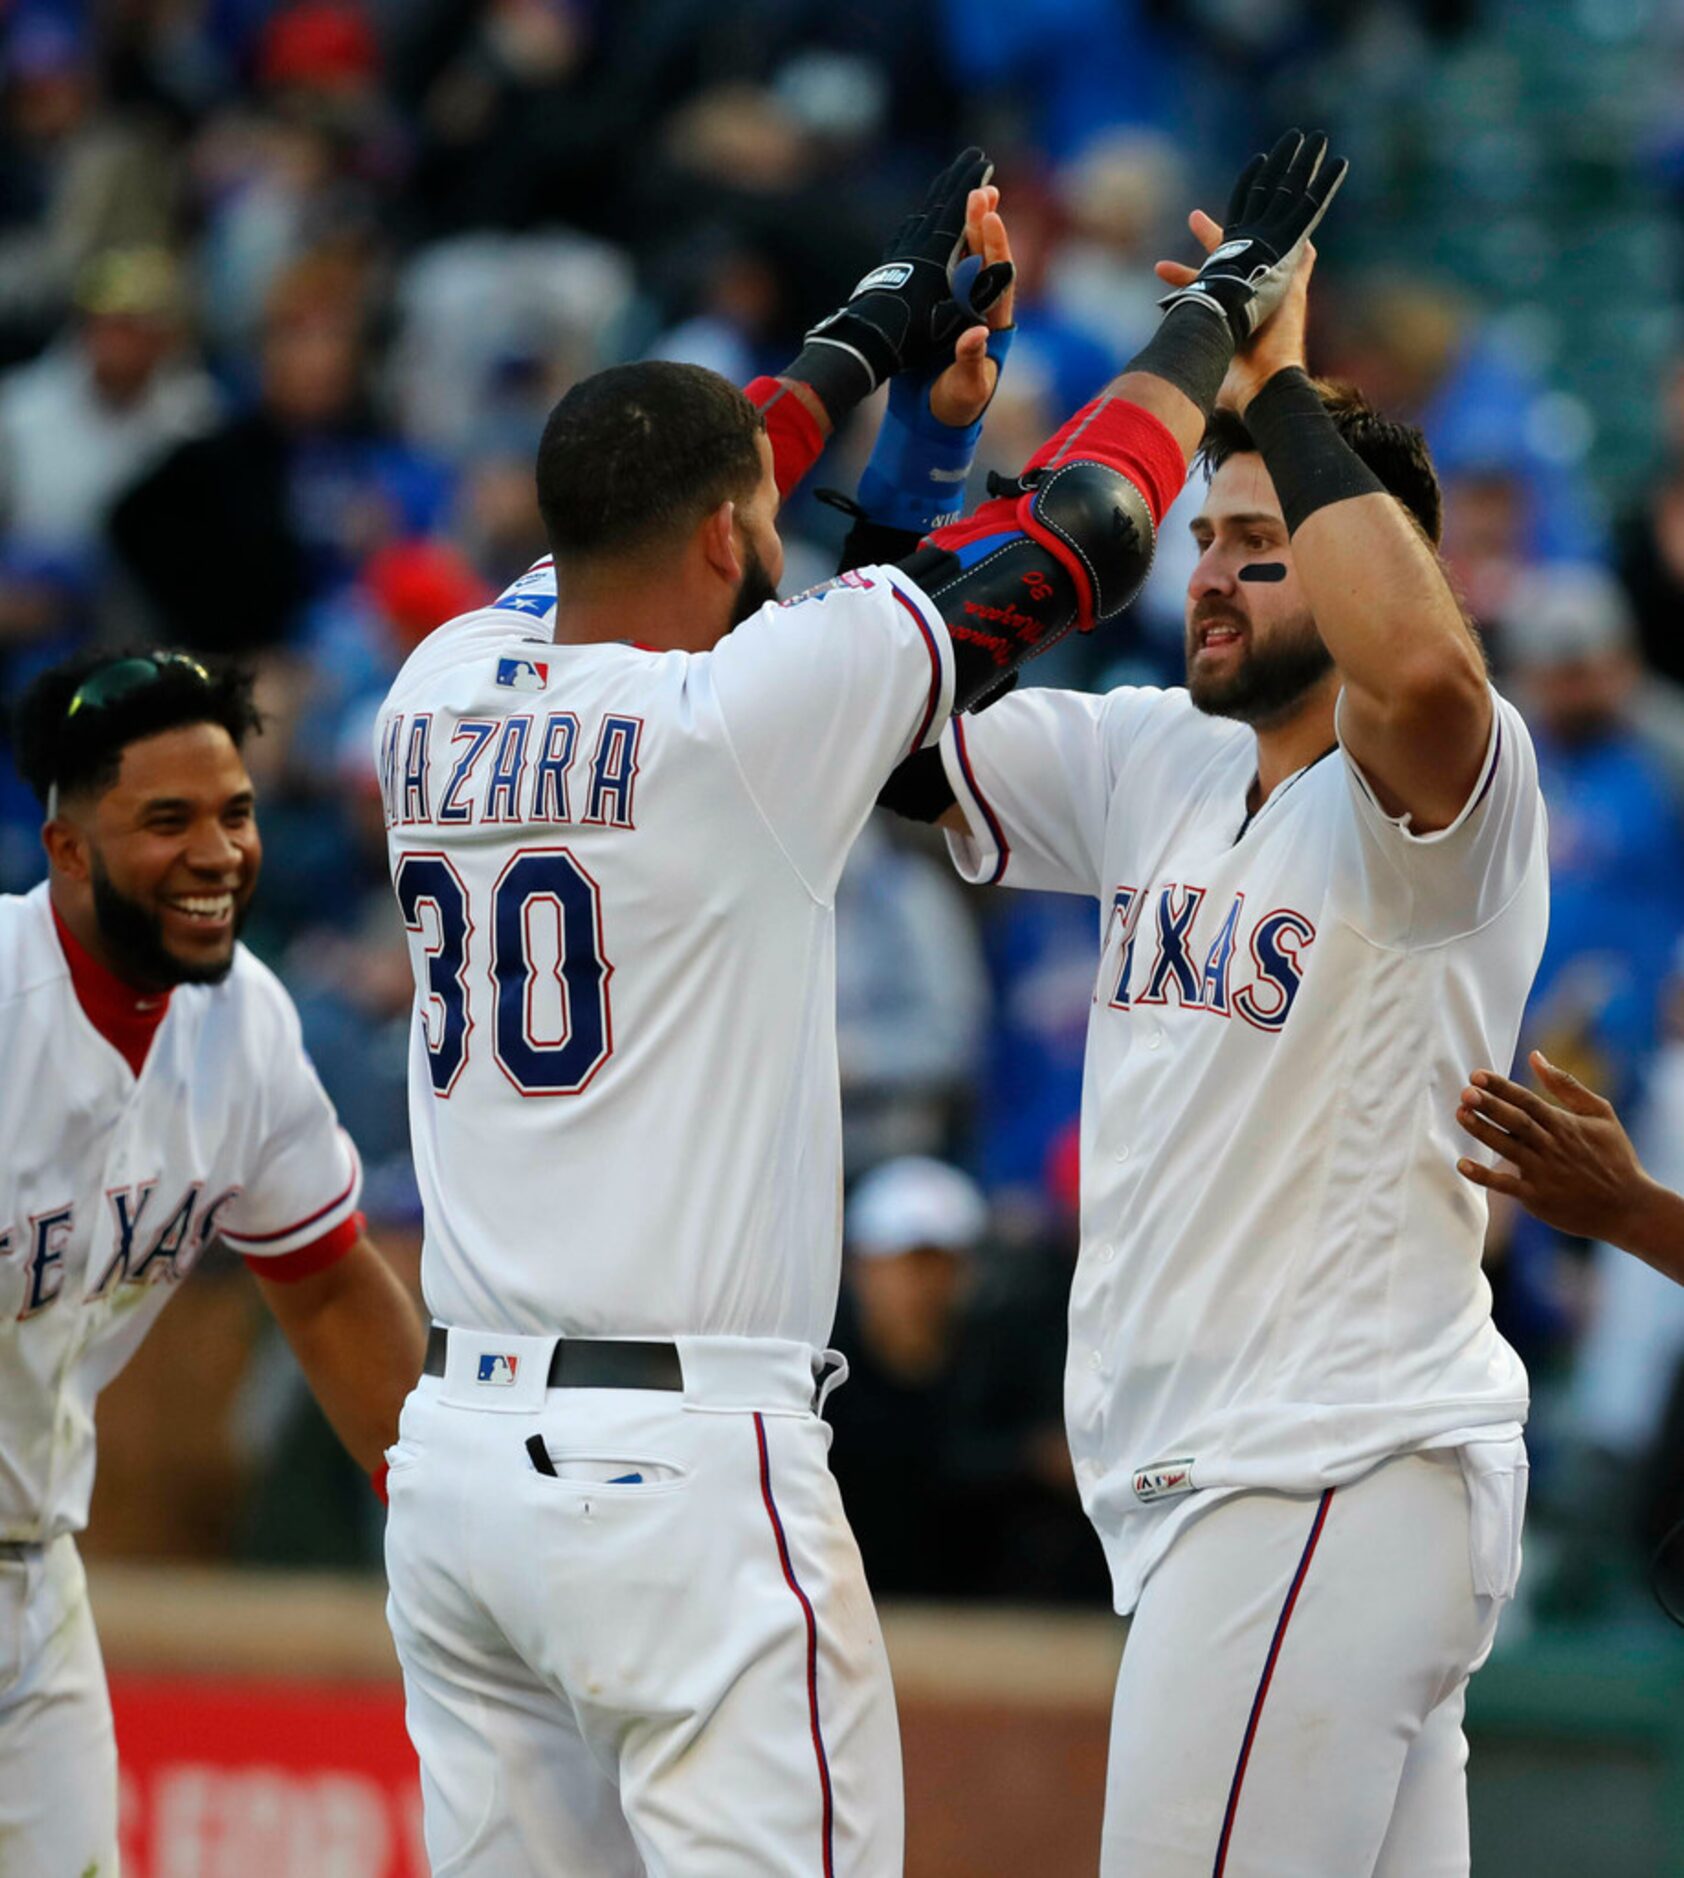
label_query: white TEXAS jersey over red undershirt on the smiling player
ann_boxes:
[0,886,360,1542]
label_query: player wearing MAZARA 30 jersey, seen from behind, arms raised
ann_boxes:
[375,152,1337,1878]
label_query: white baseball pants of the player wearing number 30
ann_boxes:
[387,1332,903,1878]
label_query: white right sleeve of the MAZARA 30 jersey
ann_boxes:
[710,567,954,901]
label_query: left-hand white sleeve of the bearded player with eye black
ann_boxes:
[941,689,1119,896]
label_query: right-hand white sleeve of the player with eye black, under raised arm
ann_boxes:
[1331,691,1547,950]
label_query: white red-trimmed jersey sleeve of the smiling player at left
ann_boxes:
[216,960,362,1258]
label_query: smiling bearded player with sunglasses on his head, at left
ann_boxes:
[0,654,422,1878]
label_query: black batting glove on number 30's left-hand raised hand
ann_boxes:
[783,146,1012,424]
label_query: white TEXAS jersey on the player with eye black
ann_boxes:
[942,689,1547,1611]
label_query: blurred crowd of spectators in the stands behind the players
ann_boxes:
[0,0,1684,1615]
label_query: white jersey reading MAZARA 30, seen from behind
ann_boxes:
[375,562,954,1345]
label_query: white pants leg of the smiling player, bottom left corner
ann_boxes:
[0,1534,116,1878]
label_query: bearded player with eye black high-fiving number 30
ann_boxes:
[878,138,1547,1878]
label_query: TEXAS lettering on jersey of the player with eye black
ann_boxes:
[1095,881,1316,1031]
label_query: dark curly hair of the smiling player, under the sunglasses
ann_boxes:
[11,648,263,806]
